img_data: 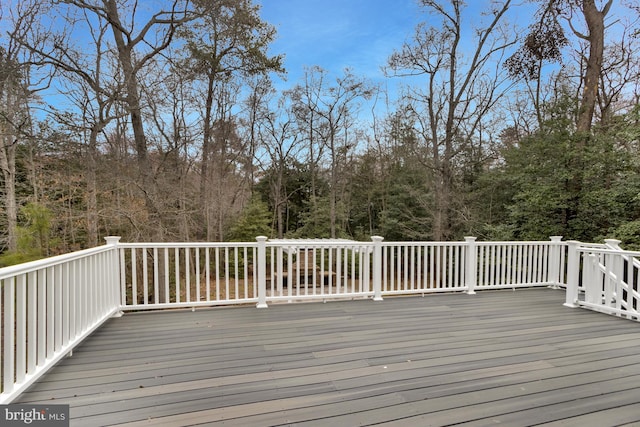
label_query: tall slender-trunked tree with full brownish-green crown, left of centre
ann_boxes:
[181,0,282,240]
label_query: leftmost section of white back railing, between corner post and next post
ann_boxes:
[118,243,258,310]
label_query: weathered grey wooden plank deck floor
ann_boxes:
[16,289,640,427]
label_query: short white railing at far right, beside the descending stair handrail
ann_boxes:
[565,239,640,320]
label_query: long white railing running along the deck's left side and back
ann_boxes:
[0,237,568,403]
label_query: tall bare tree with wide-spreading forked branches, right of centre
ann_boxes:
[388,0,515,240]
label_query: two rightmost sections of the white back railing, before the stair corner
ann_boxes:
[381,236,566,295]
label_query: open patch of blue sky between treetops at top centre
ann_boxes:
[261,0,424,86]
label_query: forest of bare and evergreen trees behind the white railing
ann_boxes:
[0,0,640,265]
